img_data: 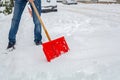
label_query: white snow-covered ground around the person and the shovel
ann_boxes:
[0,4,120,80]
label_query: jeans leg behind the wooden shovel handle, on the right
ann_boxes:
[32,0,42,42]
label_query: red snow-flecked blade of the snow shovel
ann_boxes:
[42,37,69,62]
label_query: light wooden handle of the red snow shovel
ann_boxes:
[30,1,51,41]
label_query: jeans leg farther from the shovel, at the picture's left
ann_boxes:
[8,0,27,43]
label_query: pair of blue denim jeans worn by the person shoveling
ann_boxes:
[8,0,42,43]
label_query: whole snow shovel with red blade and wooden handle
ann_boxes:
[31,2,69,62]
